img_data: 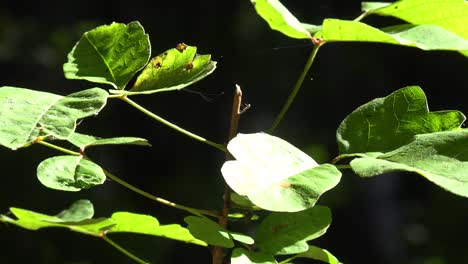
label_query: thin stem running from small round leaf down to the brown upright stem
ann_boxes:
[103,169,219,217]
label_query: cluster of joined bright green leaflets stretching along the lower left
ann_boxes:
[0,200,206,246]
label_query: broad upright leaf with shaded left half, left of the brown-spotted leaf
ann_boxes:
[63,21,151,89]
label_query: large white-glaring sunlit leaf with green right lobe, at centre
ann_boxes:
[221,133,341,211]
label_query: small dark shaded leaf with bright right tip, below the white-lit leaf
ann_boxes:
[184,216,254,248]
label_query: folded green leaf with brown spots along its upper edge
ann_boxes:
[122,43,216,94]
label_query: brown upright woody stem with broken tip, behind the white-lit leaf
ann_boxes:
[212,85,242,264]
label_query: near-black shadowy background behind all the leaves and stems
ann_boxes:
[0,0,468,264]
